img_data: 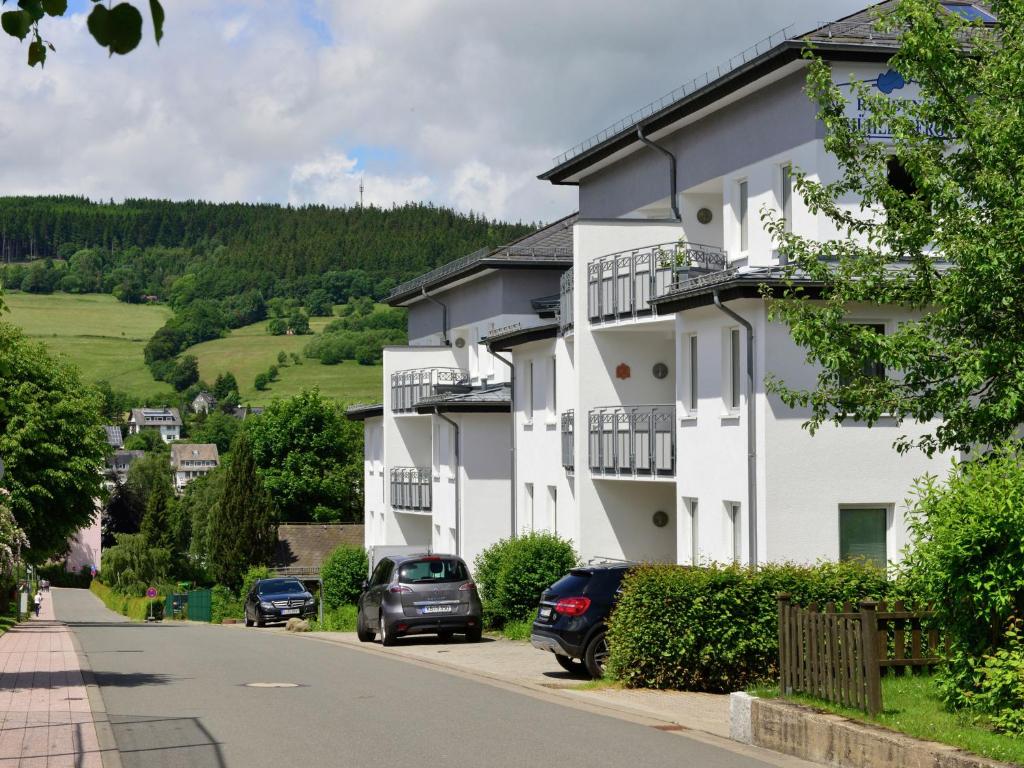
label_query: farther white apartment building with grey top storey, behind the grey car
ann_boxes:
[348,216,575,561]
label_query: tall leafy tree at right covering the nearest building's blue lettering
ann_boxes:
[764,0,1024,455]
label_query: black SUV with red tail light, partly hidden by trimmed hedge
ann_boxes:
[529,563,633,678]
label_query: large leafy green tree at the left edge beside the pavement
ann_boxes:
[0,322,109,562]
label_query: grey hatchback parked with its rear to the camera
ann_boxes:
[356,554,483,645]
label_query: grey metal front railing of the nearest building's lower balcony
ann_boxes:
[589,406,676,477]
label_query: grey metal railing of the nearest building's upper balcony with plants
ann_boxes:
[587,242,727,323]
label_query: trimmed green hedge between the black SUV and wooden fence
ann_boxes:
[608,562,889,692]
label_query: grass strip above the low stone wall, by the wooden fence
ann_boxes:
[751,675,1024,764]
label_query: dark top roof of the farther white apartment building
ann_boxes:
[386,213,577,306]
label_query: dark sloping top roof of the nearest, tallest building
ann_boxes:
[539,0,909,184]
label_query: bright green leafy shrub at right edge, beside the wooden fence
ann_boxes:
[902,444,1024,711]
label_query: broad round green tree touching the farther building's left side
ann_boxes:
[243,389,362,521]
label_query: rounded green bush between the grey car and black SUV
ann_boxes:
[473,532,580,628]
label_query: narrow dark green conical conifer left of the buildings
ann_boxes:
[207,431,278,589]
